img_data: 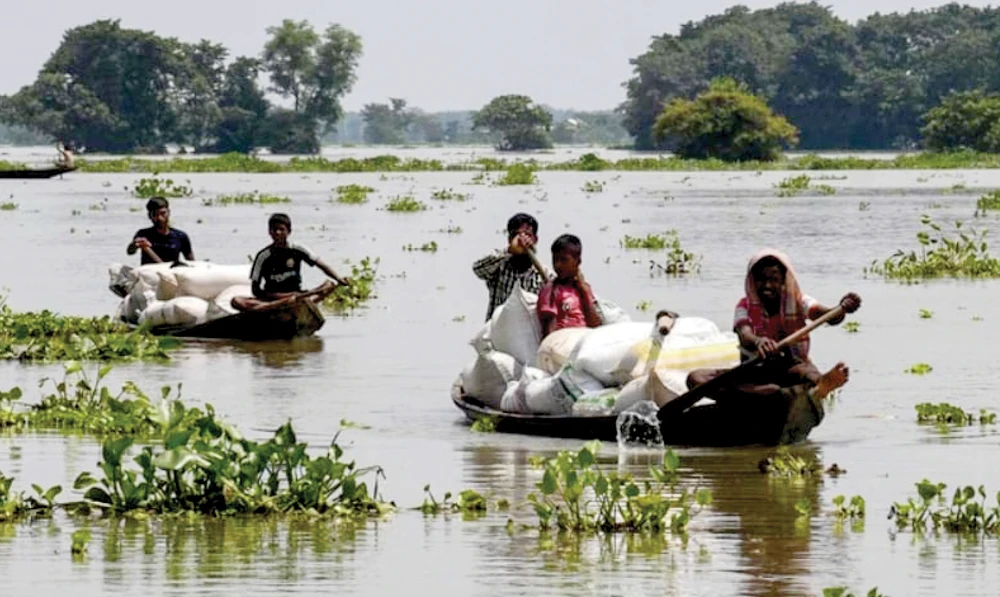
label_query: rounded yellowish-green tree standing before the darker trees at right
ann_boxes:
[653,78,798,162]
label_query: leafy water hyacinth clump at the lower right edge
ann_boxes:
[889,479,1000,535]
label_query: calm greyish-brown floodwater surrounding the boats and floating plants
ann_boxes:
[0,158,1000,596]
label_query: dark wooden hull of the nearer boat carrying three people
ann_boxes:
[451,381,823,447]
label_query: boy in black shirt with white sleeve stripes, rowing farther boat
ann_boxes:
[232,213,353,310]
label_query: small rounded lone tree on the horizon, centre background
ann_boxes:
[472,95,552,151]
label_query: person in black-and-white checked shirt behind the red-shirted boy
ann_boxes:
[472,213,544,321]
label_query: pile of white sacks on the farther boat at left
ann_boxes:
[109,261,252,327]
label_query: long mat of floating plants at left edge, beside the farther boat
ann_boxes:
[0,299,180,361]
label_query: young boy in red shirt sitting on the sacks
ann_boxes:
[536,234,601,338]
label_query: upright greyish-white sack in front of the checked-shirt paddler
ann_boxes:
[470,287,542,365]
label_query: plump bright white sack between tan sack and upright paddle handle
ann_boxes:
[569,322,654,386]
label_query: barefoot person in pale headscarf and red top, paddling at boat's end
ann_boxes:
[688,249,861,408]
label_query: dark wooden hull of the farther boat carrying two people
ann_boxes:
[150,297,326,341]
